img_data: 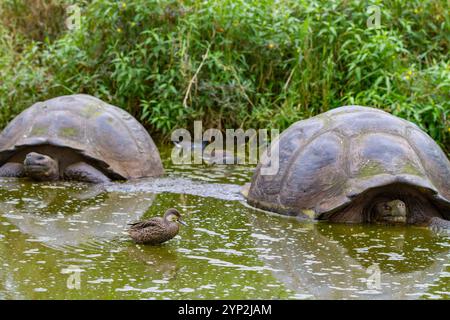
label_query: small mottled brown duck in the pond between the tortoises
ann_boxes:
[128,208,187,245]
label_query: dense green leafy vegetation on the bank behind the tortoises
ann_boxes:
[0,0,450,151]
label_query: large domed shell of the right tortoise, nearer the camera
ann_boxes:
[247,106,450,219]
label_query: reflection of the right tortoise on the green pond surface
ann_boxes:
[249,213,450,299]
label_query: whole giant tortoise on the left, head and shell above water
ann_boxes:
[0,94,163,183]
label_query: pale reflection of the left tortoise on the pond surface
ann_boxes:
[0,179,155,247]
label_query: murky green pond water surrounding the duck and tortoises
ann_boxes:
[0,146,450,299]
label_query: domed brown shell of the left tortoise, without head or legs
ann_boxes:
[0,94,163,179]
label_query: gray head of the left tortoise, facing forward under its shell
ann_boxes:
[23,152,59,181]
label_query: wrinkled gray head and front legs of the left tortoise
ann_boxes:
[0,152,111,183]
